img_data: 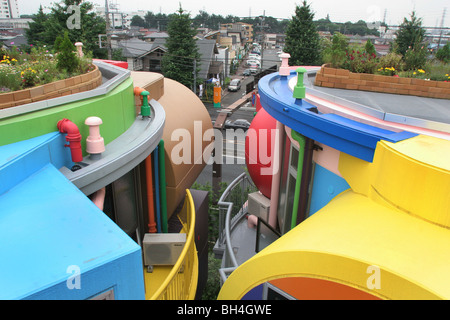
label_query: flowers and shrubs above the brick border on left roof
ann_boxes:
[0,32,94,94]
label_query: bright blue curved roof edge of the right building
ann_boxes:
[258,72,417,162]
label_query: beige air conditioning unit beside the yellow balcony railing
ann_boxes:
[143,233,186,267]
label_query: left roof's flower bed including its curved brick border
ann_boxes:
[0,43,102,109]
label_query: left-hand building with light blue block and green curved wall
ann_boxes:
[0,61,212,300]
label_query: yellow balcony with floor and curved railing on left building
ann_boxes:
[144,190,198,300]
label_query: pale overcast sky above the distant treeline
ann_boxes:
[18,0,450,27]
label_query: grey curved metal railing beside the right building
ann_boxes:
[215,172,257,268]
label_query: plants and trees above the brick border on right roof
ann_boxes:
[322,11,450,82]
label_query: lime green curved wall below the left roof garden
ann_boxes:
[0,78,136,154]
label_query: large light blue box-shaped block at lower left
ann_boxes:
[0,134,145,300]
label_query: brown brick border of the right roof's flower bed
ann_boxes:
[314,65,450,99]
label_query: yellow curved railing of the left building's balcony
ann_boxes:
[150,190,198,300]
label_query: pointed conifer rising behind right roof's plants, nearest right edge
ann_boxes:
[395,11,425,56]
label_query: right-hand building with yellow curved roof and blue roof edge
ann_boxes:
[216,56,450,300]
